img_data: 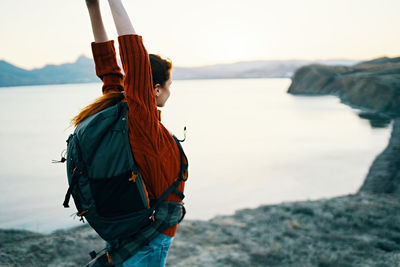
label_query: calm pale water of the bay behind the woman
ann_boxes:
[0,79,391,232]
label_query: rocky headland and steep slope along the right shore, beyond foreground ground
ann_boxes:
[288,57,400,195]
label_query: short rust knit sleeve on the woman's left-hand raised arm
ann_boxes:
[92,40,124,93]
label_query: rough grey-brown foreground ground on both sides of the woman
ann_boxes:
[0,194,400,267]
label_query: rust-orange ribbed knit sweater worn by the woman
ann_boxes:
[92,35,184,236]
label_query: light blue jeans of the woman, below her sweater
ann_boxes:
[122,234,173,267]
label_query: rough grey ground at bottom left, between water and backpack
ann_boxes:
[0,225,104,267]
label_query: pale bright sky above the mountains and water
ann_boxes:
[0,0,400,69]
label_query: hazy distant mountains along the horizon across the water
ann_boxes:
[0,56,359,87]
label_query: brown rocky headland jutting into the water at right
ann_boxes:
[288,57,400,116]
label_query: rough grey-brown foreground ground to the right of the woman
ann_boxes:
[168,194,400,267]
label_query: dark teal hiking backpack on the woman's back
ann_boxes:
[62,102,188,245]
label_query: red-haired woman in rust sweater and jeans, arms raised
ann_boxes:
[73,0,184,267]
